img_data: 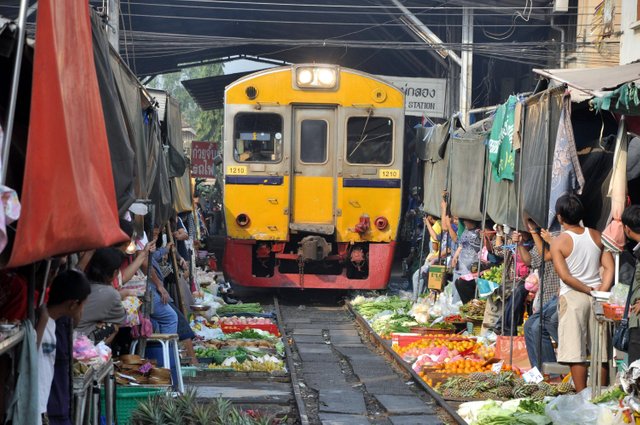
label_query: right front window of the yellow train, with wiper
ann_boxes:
[347,116,393,164]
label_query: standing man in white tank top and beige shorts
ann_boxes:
[551,195,614,392]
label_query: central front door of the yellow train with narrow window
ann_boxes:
[290,107,337,235]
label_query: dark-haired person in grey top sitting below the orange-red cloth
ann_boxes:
[77,248,126,343]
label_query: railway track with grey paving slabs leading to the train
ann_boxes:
[273,291,465,425]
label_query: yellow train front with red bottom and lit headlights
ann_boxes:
[223,64,404,289]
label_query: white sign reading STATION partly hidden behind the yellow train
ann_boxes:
[380,75,447,118]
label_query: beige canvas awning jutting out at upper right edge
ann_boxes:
[533,62,640,96]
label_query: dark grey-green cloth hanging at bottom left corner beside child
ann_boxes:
[7,320,42,425]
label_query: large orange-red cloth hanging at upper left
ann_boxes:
[8,0,127,267]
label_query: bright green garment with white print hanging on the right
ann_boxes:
[489,95,519,181]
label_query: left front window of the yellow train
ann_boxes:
[233,112,282,162]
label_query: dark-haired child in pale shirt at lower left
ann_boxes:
[36,270,91,423]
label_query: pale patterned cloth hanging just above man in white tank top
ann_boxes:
[548,94,584,228]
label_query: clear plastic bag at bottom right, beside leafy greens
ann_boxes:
[545,388,600,425]
